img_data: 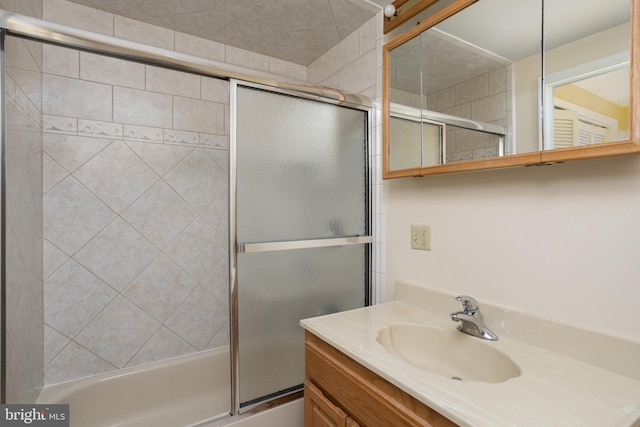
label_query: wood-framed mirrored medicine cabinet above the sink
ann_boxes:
[383,0,640,178]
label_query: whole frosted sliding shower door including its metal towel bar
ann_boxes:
[232,84,371,410]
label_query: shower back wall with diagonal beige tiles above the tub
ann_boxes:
[43,46,229,384]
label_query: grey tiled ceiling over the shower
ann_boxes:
[63,0,391,66]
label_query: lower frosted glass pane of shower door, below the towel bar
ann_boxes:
[238,245,366,404]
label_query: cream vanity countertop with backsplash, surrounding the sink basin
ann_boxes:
[301,283,640,427]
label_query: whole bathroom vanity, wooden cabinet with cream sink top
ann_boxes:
[301,283,640,427]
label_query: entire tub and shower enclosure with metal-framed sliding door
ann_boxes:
[0,12,371,426]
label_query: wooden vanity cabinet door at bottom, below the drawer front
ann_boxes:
[304,381,358,427]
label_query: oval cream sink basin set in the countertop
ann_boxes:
[376,323,521,383]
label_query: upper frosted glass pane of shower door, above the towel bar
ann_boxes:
[236,86,367,243]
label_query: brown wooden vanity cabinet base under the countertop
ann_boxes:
[304,331,456,427]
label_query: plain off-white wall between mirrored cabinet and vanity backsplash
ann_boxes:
[384,156,640,340]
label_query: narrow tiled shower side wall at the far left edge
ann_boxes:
[0,0,44,403]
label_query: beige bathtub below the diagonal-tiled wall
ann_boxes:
[38,347,231,427]
